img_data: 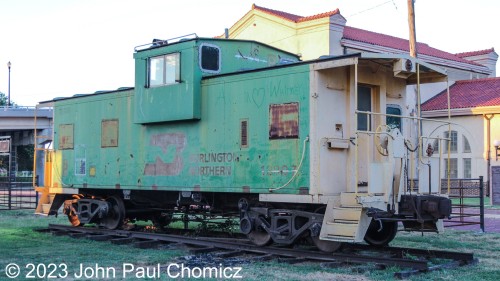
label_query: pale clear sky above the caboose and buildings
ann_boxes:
[0,0,500,106]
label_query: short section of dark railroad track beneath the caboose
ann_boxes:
[39,224,477,278]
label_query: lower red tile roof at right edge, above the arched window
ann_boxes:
[421,77,500,111]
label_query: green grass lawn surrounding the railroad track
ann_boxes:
[0,210,500,281]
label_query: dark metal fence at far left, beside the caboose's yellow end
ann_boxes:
[0,177,38,210]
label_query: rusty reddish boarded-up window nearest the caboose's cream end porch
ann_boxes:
[269,102,299,139]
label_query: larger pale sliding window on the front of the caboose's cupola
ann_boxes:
[148,53,181,87]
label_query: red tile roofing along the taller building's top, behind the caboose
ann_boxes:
[252,4,483,66]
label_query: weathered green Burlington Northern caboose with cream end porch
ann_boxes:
[33,34,449,250]
